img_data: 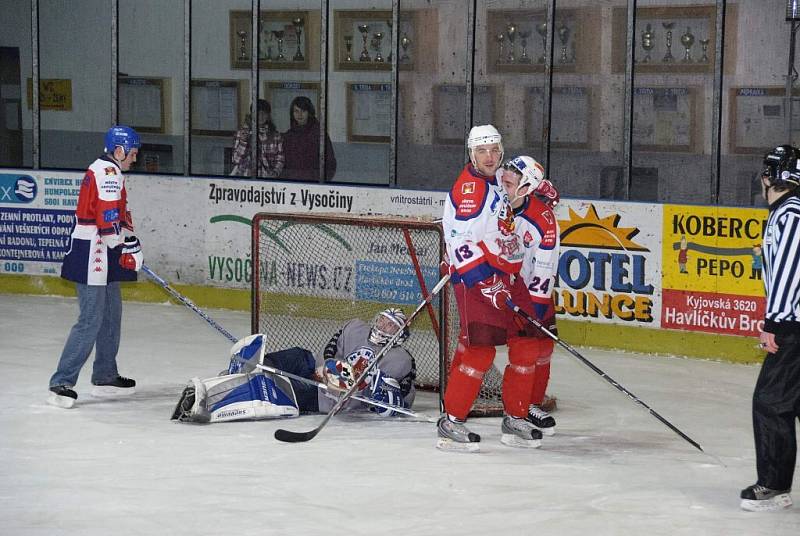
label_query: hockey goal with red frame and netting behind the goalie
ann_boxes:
[251,213,501,415]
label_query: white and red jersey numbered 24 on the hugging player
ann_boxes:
[514,196,561,305]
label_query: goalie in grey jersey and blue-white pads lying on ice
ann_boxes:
[172,309,416,422]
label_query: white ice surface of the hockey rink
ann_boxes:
[0,295,800,536]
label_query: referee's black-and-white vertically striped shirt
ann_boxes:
[764,194,800,333]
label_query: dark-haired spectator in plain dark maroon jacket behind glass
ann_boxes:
[282,97,336,181]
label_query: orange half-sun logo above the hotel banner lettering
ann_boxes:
[558,204,650,251]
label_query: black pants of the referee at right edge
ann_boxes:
[753,332,800,490]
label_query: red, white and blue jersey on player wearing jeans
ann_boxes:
[61,155,136,285]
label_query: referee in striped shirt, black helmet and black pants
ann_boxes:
[740,145,800,511]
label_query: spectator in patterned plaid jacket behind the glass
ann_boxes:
[231,99,284,178]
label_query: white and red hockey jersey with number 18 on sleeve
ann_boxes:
[442,164,525,287]
